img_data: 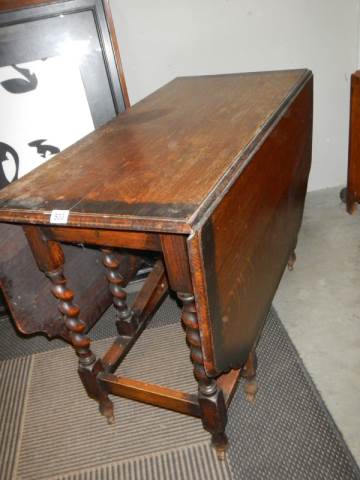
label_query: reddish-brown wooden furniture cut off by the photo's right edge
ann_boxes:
[346,71,360,213]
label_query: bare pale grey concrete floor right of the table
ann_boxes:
[274,187,360,465]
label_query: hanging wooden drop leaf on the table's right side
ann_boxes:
[189,79,313,375]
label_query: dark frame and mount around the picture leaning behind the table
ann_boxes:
[0,0,130,316]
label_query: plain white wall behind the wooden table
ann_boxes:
[110,0,360,190]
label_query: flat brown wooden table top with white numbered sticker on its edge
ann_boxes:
[0,70,310,233]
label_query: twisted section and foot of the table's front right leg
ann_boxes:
[178,293,228,460]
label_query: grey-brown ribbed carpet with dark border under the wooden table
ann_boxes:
[0,300,360,480]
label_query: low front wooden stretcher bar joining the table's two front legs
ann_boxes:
[98,373,201,417]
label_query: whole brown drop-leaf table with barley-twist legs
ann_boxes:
[0,70,313,457]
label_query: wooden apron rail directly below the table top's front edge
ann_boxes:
[44,227,162,252]
